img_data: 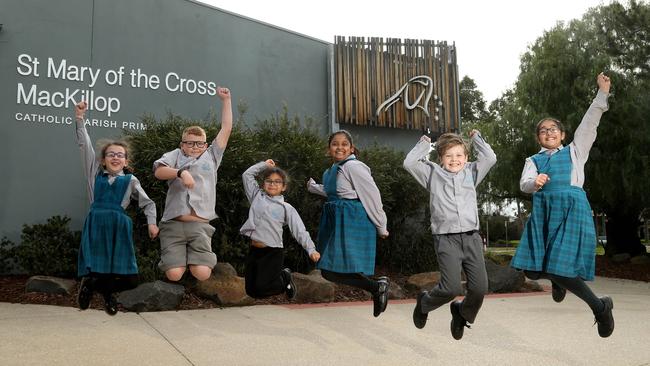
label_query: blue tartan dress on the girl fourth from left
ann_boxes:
[316,158,377,275]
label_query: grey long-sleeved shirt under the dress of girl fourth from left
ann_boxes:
[307,160,388,235]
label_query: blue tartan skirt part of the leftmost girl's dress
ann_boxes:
[77,202,138,277]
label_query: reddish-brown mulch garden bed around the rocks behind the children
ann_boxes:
[0,256,650,310]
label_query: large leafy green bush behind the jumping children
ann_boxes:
[127,108,436,279]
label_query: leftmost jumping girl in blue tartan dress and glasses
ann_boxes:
[75,101,158,315]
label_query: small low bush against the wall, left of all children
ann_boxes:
[0,216,81,277]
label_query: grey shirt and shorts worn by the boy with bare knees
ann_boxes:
[153,143,224,272]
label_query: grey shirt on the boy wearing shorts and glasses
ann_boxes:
[153,141,224,222]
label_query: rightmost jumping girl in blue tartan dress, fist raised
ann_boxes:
[511,73,614,337]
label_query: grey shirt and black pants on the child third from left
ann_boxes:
[239,162,316,298]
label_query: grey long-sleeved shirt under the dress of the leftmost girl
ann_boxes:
[76,119,156,224]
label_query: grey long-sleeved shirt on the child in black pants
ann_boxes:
[239,161,316,254]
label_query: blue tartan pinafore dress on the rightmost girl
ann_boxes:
[510,147,596,281]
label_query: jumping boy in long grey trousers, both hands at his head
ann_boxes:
[404,130,496,339]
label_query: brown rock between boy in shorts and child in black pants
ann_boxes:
[194,263,253,305]
